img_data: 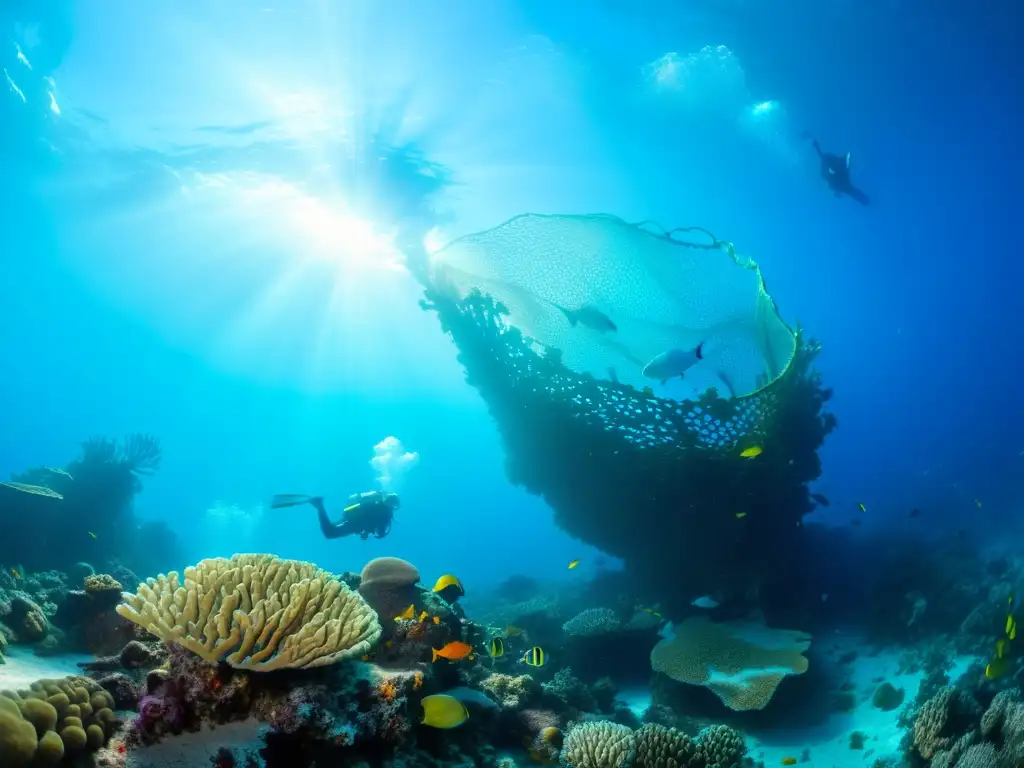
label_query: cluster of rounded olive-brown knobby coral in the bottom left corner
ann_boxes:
[0,677,117,768]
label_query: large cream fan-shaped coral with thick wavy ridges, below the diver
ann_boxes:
[117,555,381,672]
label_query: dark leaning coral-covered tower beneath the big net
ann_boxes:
[424,268,835,613]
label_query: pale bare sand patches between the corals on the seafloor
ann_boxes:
[0,636,976,768]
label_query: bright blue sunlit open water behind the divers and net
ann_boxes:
[0,1,1024,584]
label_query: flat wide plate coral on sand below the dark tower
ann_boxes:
[650,615,811,712]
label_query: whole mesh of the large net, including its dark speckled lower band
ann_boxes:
[427,215,800,449]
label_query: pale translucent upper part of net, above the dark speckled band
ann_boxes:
[430,214,798,398]
